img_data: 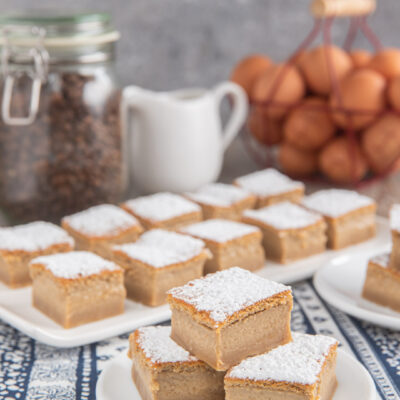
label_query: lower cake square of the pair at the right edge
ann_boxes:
[362,253,400,312]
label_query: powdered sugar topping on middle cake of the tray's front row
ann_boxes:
[181,219,260,243]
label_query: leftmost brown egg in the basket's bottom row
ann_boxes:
[278,143,318,176]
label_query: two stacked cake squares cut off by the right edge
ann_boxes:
[362,204,400,312]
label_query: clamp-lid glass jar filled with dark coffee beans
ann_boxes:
[0,14,126,222]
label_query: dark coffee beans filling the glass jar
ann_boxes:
[0,72,122,222]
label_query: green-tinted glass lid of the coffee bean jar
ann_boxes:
[0,10,119,47]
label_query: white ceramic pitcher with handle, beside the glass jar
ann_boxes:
[121,82,248,193]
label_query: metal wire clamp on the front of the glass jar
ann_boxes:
[1,26,49,126]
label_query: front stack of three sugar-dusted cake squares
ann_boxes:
[128,267,338,400]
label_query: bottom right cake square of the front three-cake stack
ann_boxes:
[225,333,338,400]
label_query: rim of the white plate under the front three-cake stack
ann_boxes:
[95,348,378,400]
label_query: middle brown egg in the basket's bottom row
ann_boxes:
[319,137,367,184]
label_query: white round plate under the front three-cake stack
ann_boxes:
[96,349,376,400]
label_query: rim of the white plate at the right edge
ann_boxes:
[313,251,400,330]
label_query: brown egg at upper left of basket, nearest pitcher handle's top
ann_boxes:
[231,54,272,96]
